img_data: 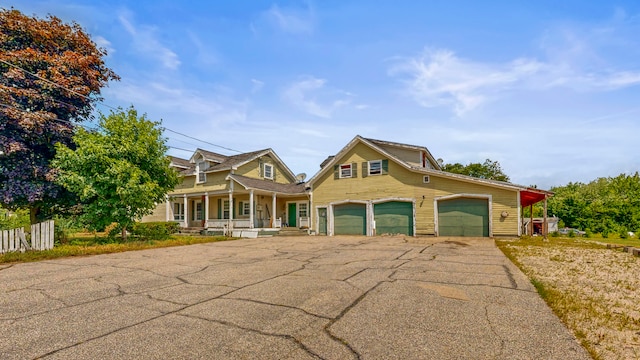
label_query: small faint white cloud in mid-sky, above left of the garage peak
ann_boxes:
[283,77,351,118]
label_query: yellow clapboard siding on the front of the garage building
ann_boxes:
[313,143,518,236]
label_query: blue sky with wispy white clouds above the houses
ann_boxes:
[8,0,640,188]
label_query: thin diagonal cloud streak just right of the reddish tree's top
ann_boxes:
[118,13,180,70]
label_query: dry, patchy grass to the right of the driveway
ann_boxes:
[496,238,640,359]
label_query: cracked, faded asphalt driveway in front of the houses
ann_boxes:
[0,236,590,360]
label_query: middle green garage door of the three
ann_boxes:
[373,201,413,236]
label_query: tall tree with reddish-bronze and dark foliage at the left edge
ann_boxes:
[0,9,118,223]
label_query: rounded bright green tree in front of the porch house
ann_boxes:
[53,107,178,238]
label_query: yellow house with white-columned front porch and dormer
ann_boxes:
[142,149,310,232]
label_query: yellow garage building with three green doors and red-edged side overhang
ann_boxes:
[306,136,551,237]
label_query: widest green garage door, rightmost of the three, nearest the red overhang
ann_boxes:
[438,198,489,237]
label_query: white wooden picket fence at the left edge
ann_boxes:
[0,220,54,254]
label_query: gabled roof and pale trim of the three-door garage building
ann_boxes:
[307,135,553,197]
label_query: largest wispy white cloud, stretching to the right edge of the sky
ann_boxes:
[389,9,640,116]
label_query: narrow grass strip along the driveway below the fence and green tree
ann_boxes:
[0,233,230,264]
